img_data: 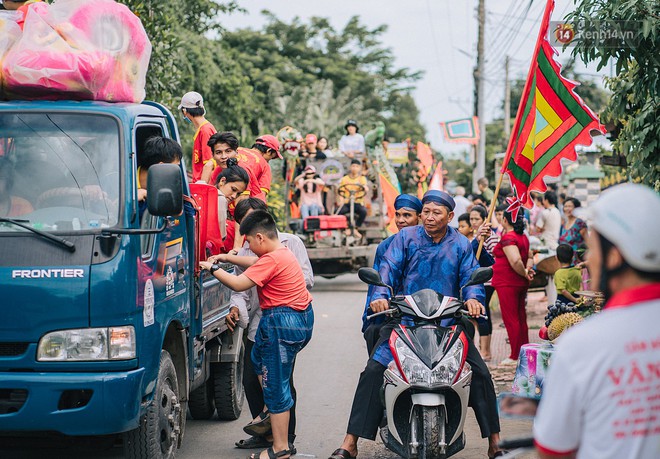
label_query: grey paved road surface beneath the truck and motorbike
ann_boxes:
[0,275,531,459]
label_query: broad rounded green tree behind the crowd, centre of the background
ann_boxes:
[222,11,425,140]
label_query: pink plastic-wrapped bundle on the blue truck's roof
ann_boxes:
[0,0,151,102]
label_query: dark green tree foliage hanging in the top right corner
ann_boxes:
[567,0,660,190]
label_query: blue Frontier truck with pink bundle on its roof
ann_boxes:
[0,101,244,458]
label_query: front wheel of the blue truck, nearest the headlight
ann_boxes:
[123,350,180,459]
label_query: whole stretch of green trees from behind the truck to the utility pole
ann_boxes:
[120,0,425,146]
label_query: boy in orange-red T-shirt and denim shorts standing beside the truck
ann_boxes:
[200,210,314,459]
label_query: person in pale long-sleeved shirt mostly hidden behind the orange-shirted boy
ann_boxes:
[208,198,314,449]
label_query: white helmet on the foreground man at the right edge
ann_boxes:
[589,183,660,272]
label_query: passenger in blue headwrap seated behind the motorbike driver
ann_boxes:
[362,194,422,355]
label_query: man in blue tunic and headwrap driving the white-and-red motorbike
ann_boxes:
[330,190,502,459]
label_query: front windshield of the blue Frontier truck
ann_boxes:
[0,113,120,232]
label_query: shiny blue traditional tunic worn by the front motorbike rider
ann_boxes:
[372,226,486,366]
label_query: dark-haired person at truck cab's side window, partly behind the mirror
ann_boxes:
[137,136,183,221]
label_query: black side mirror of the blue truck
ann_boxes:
[147,164,183,217]
